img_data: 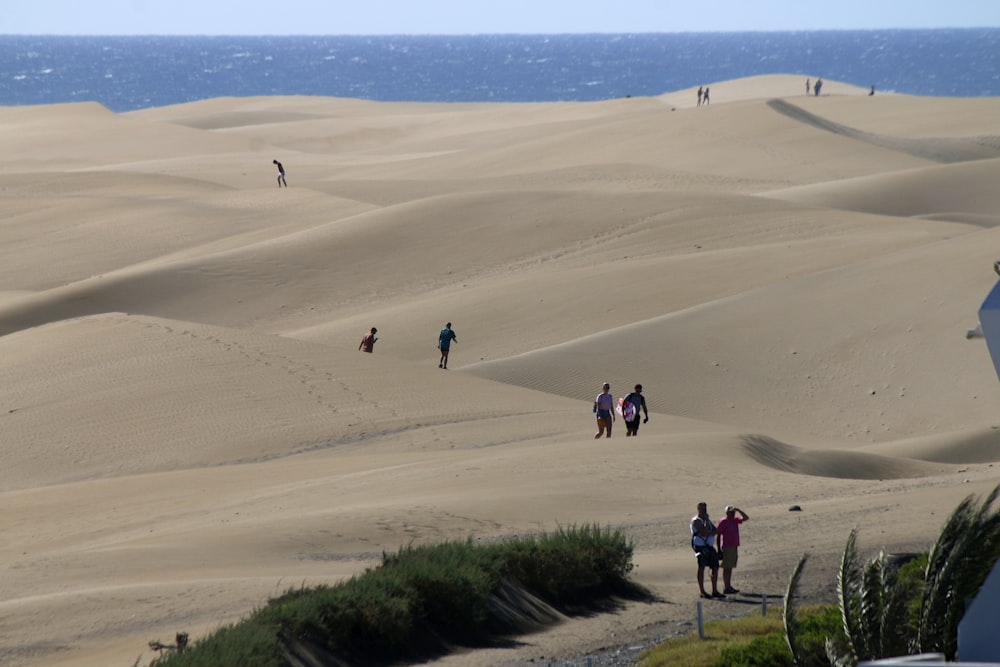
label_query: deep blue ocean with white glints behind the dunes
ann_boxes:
[0,28,1000,112]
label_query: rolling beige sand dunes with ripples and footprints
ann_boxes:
[0,76,1000,667]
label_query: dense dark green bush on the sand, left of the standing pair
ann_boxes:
[152,525,647,667]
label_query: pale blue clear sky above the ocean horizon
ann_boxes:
[0,0,1000,35]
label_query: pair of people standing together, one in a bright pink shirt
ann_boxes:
[691,502,750,598]
